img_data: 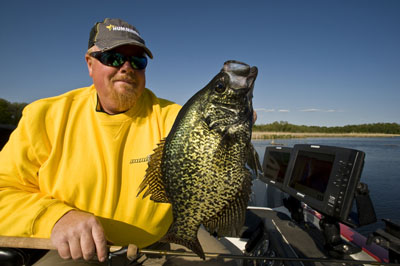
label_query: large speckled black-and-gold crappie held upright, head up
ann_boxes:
[138,60,261,259]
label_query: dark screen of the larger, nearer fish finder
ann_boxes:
[289,151,335,201]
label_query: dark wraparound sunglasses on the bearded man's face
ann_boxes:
[89,51,147,69]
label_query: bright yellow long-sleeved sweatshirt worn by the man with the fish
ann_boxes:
[0,85,180,247]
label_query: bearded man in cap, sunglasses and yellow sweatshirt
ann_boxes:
[0,19,236,265]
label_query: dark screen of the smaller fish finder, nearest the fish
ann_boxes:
[264,151,290,183]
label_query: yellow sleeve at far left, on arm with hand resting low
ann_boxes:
[0,106,73,238]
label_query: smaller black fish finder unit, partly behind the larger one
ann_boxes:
[260,146,292,190]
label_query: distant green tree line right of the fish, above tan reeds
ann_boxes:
[253,121,400,134]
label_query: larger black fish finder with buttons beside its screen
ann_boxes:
[282,144,365,226]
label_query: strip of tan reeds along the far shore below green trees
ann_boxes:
[252,131,400,140]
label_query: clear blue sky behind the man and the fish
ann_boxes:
[0,0,400,126]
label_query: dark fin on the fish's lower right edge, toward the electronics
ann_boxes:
[203,172,251,236]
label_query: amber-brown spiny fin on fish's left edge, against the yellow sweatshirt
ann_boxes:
[137,139,169,203]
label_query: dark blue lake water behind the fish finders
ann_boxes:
[253,137,400,235]
